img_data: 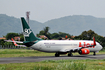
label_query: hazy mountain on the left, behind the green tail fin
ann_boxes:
[0,14,45,37]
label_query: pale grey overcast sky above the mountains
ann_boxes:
[0,0,105,23]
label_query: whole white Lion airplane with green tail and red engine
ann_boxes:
[6,17,102,57]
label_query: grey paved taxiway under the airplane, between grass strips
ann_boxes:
[0,54,105,64]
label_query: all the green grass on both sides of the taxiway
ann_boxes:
[0,49,105,70]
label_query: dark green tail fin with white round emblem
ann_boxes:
[21,17,42,42]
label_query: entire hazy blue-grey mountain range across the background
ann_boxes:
[0,14,105,37]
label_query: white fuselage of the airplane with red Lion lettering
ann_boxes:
[31,40,102,52]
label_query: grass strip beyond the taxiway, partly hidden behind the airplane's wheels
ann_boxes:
[0,49,105,58]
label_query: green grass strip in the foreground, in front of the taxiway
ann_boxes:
[0,59,105,70]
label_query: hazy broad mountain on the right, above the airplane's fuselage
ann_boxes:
[44,15,105,36]
